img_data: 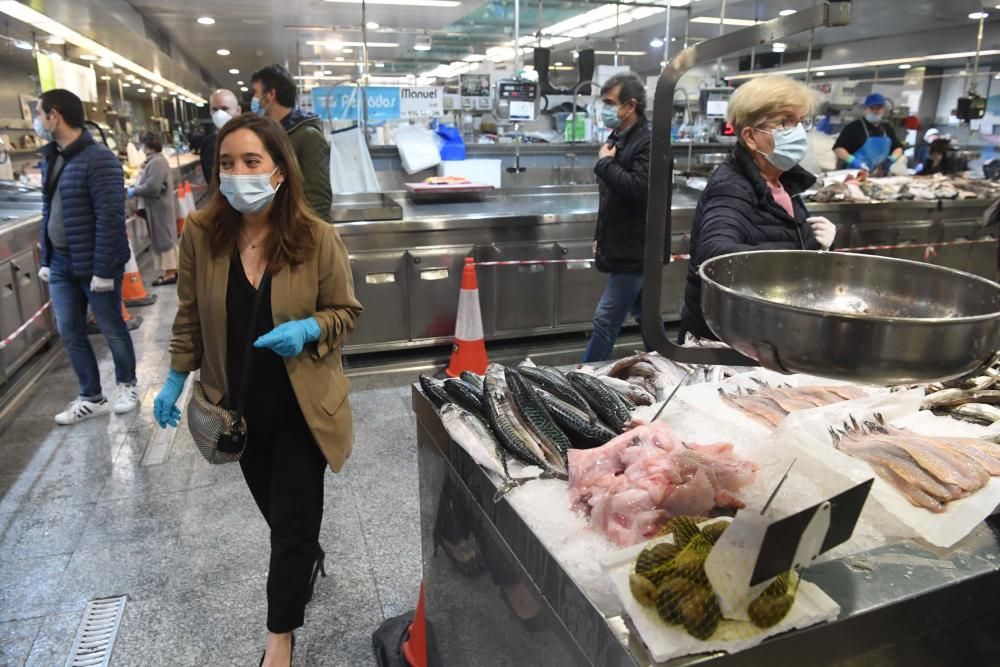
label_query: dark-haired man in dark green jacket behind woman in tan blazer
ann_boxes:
[250,65,333,222]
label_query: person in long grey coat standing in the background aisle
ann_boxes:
[128,132,177,286]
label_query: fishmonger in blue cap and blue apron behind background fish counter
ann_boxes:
[833,93,903,176]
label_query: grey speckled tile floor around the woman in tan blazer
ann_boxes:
[0,268,421,667]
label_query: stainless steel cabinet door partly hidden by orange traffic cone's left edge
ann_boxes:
[406,245,472,340]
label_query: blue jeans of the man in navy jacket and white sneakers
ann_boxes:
[49,252,135,399]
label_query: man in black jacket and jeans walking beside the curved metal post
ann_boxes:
[583,73,652,362]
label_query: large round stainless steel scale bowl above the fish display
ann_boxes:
[700,250,1000,384]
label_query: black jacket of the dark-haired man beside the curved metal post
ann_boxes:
[594,120,652,273]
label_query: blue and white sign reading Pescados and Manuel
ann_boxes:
[312,86,444,122]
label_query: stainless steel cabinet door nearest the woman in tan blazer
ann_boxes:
[347,250,409,347]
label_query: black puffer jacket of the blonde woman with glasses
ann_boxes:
[681,145,820,339]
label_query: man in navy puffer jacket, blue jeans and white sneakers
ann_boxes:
[34,89,139,425]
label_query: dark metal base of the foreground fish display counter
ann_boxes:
[412,385,1000,667]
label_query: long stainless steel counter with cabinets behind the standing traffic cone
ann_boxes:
[338,186,997,352]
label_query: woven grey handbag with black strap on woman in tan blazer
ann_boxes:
[187,274,271,463]
